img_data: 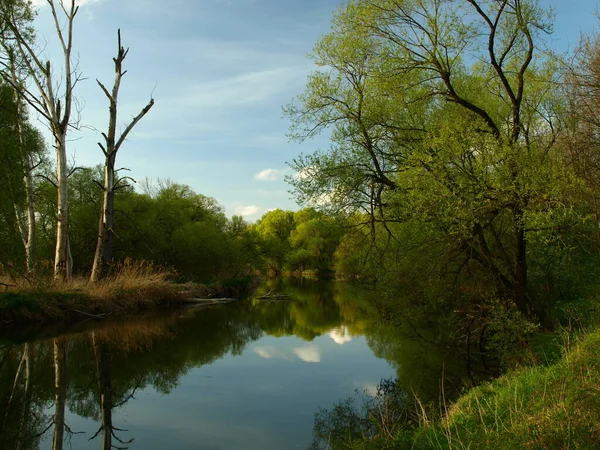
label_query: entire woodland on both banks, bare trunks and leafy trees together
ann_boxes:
[0,0,600,448]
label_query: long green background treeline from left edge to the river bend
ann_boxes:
[0,155,370,282]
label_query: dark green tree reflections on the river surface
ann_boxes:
[0,279,462,450]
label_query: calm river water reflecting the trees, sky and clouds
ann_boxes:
[0,280,472,450]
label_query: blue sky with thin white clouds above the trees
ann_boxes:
[28,0,600,221]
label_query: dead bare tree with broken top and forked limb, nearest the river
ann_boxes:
[90,30,154,282]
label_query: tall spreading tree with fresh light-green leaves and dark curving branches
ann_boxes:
[288,0,570,313]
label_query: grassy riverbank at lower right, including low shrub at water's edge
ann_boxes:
[312,328,600,450]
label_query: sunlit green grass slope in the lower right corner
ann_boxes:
[412,331,600,450]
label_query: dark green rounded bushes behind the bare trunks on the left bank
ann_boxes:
[29,172,259,282]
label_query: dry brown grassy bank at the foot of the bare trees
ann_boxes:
[0,265,252,324]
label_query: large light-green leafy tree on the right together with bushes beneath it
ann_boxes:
[286,0,597,319]
